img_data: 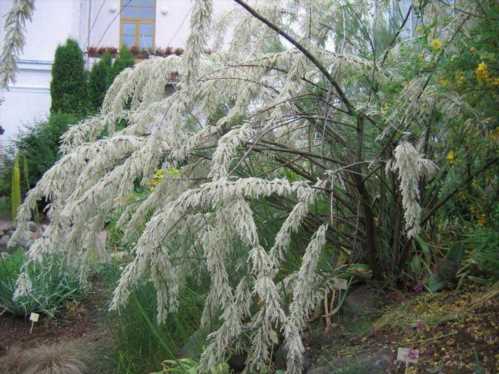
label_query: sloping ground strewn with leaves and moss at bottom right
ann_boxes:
[309,284,499,374]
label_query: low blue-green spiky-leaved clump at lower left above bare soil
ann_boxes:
[0,250,83,317]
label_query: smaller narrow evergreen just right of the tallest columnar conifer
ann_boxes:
[88,53,113,112]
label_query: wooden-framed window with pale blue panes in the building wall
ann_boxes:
[121,0,156,48]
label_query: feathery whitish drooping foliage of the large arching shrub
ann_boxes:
[4,0,464,373]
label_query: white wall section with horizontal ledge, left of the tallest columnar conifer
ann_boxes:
[0,0,80,145]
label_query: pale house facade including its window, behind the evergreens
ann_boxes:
[0,0,233,143]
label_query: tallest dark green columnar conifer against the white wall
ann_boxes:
[50,39,88,116]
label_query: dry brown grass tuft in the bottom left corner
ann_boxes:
[0,344,87,374]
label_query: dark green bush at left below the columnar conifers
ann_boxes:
[15,113,78,188]
